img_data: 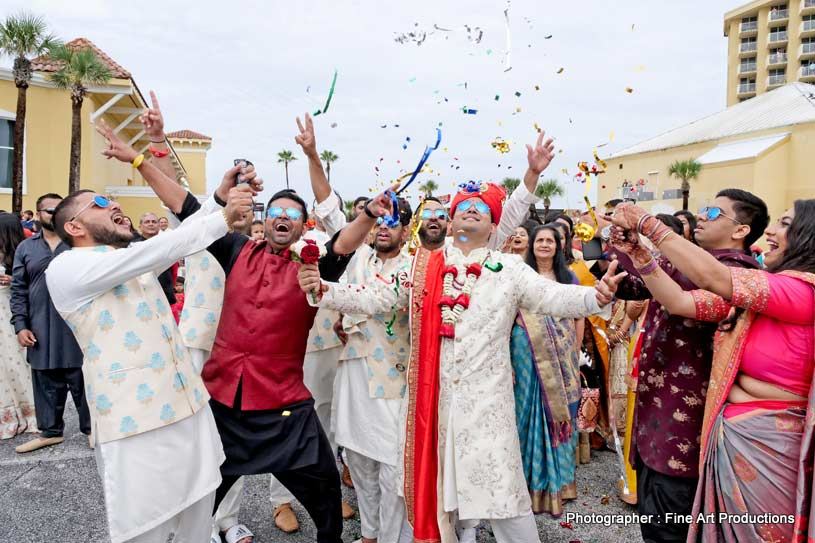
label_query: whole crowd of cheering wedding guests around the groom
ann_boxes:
[0,90,815,543]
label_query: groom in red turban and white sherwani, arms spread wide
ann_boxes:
[300,164,622,543]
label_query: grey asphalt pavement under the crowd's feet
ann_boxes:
[0,400,642,543]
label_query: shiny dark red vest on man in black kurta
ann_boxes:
[201,242,317,411]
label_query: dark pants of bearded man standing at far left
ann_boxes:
[31,368,91,437]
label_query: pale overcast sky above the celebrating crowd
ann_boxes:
[3,0,744,207]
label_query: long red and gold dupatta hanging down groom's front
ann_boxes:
[404,249,444,543]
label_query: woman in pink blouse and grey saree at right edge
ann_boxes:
[612,200,815,543]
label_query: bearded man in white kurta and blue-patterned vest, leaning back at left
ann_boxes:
[46,128,253,543]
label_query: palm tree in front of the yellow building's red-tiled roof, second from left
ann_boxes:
[48,45,112,194]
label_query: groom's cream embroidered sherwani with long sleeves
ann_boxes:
[319,247,608,541]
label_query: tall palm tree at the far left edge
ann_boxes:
[0,12,59,213]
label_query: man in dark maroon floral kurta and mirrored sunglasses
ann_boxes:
[616,189,769,543]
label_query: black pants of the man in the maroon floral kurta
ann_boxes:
[637,460,699,543]
